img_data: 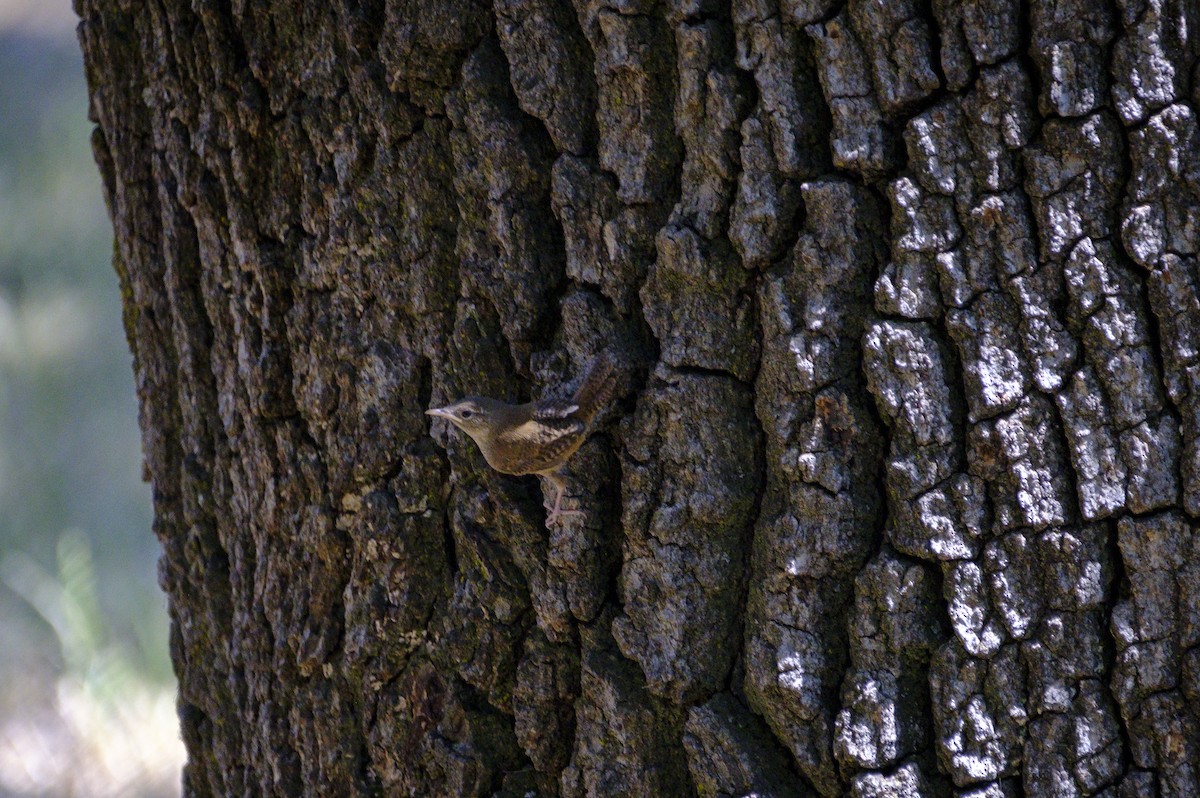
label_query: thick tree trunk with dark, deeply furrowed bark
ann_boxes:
[77,0,1200,798]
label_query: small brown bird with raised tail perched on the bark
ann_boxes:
[425,354,617,527]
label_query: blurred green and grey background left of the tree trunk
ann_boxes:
[0,0,182,796]
